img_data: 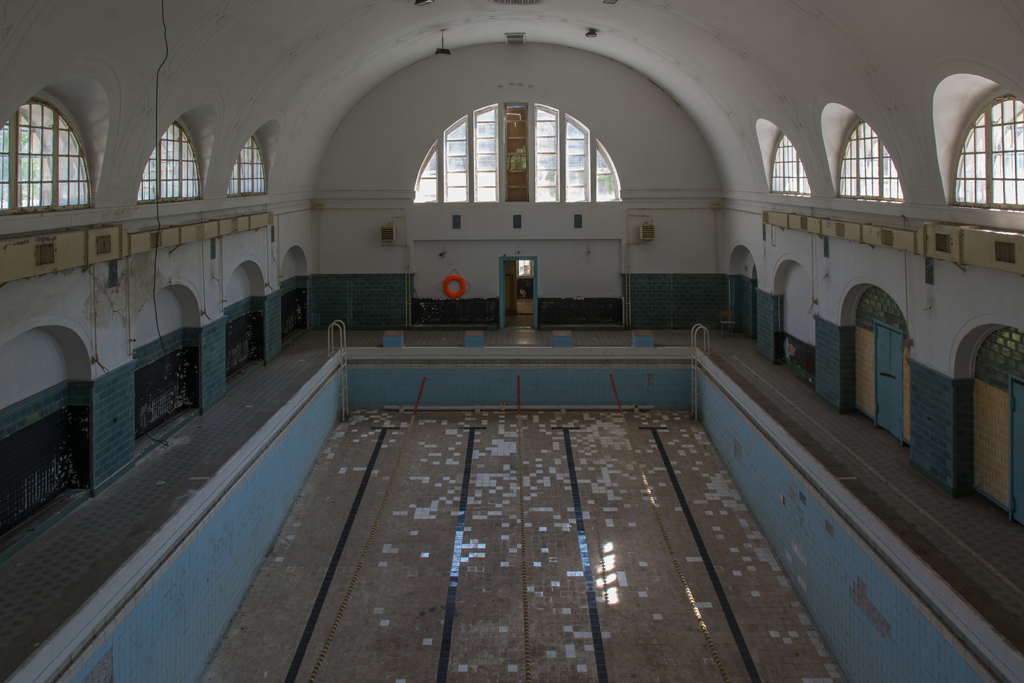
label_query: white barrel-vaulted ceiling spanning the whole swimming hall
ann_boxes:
[0,0,1024,207]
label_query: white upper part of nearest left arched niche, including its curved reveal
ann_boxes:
[0,326,92,410]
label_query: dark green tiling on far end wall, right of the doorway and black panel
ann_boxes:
[623,273,729,330]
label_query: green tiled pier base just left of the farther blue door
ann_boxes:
[814,315,857,413]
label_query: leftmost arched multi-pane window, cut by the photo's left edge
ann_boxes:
[0,101,89,211]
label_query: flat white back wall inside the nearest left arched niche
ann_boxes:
[0,330,68,410]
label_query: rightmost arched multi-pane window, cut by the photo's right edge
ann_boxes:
[955,97,1024,207]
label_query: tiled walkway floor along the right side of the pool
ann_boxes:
[712,330,1024,650]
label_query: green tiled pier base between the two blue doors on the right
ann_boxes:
[909,360,974,496]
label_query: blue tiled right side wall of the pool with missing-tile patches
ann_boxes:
[697,374,982,683]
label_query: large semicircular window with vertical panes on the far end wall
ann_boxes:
[414,103,620,204]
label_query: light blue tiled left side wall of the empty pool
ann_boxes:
[67,376,340,683]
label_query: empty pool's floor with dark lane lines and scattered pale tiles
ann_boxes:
[197,411,840,683]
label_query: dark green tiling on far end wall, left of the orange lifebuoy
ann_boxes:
[307,272,406,328]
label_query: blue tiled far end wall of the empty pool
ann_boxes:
[348,364,692,410]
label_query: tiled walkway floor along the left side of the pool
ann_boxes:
[0,333,327,680]
